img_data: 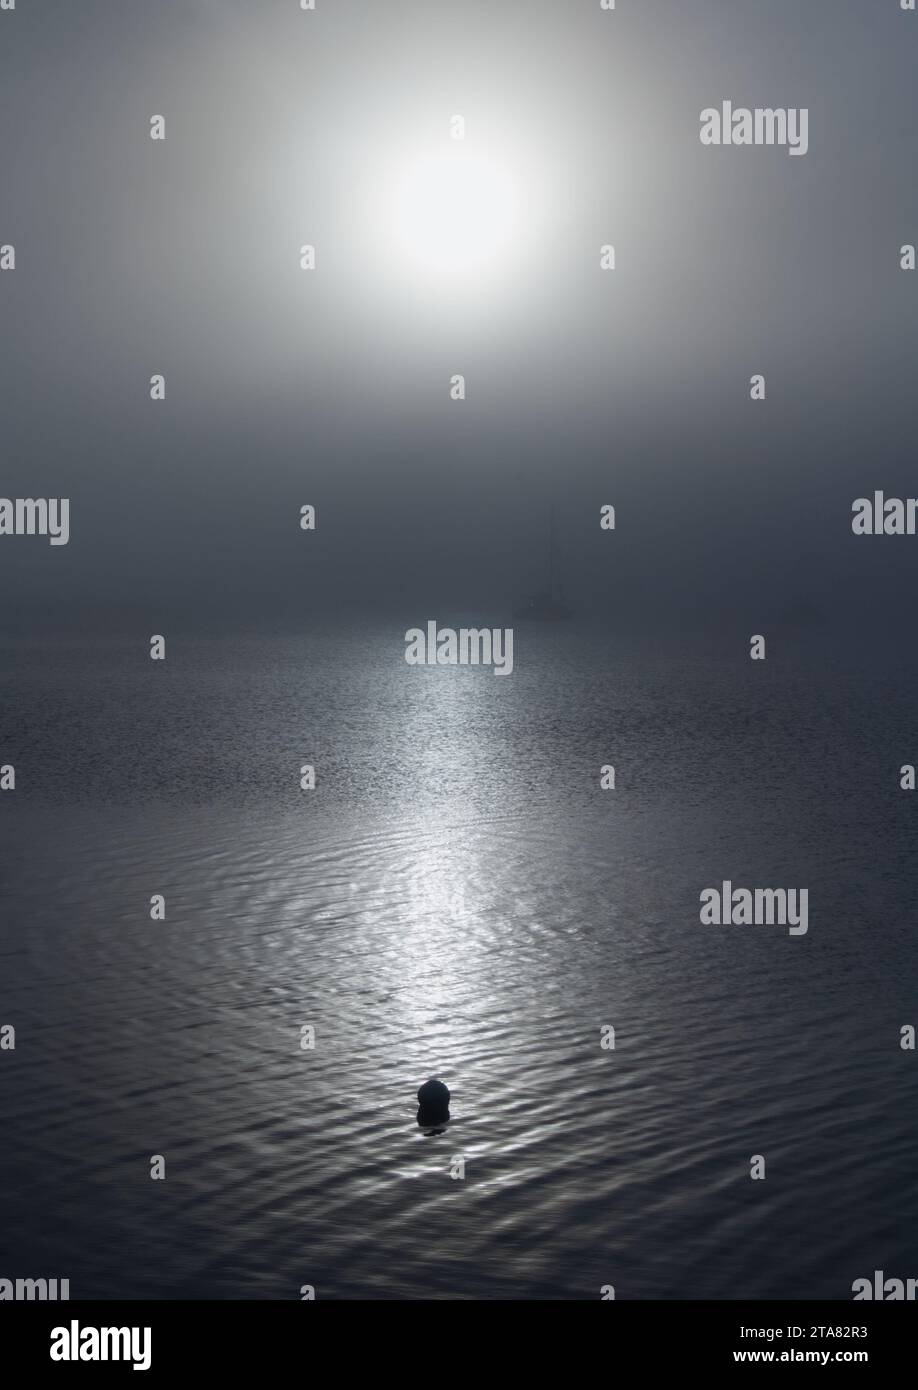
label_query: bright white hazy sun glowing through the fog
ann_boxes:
[388,142,516,281]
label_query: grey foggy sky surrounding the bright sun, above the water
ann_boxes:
[0,0,918,637]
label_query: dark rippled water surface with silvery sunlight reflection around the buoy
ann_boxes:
[0,623,918,1298]
